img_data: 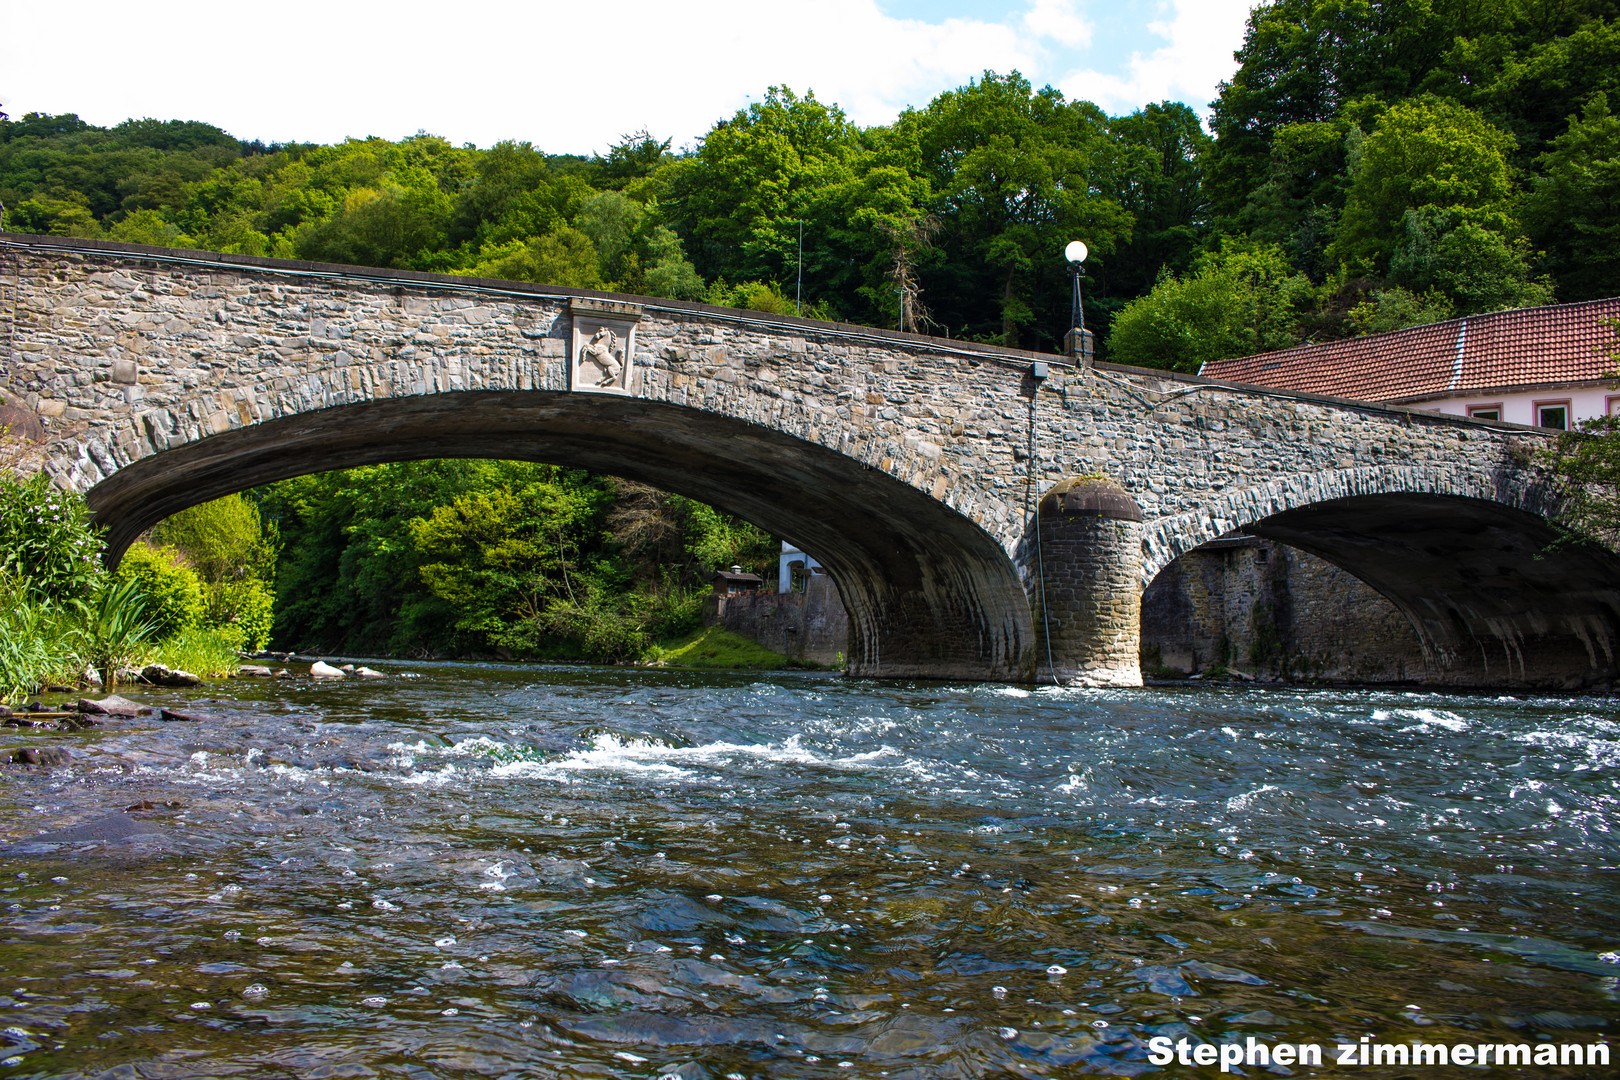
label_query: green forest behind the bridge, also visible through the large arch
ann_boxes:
[0,0,1620,656]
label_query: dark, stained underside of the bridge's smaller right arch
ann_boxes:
[1243,492,1620,690]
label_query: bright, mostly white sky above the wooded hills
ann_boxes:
[0,0,1256,154]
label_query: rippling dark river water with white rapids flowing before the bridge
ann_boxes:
[0,664,1620,1080]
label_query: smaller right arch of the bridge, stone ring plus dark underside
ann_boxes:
[1142,463,1620,688]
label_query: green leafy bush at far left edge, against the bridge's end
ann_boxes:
[0,473,102,601]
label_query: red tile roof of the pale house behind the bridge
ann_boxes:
[1199,298,1620,402]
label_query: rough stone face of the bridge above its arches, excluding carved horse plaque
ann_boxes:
[0,238,1531,566]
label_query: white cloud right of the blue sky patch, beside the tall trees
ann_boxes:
[1058,0,1254,115]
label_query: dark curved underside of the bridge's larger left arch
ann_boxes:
[86,390,1034,680]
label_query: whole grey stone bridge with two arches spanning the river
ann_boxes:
[0,235,1620,687]
